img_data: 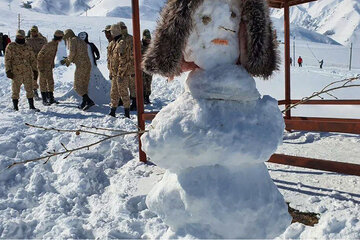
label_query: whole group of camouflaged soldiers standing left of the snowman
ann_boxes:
[5,22,152,118]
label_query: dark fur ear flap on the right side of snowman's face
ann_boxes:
[239,0,279,78]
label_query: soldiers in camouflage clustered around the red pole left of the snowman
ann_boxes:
[104,22,152,117]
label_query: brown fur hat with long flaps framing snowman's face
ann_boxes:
[143,0,279,78]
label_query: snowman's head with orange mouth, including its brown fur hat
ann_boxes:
[143,0,279,78]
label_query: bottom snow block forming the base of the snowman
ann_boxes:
[146,164,291,239]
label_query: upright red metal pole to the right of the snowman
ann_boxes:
[284,0,295,119]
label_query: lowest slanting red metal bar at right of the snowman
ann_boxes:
[268,154,360,176]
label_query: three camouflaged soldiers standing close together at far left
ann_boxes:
[5,26,64,112]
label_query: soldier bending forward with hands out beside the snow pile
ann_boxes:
[61,29,95,111]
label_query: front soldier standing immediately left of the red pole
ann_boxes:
[108,24,130,118]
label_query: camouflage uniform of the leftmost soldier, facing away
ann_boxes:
[5,34,37,99]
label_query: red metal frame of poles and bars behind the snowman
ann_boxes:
[132,0,360,176]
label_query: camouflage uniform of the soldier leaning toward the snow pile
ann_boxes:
[67,37,91,96]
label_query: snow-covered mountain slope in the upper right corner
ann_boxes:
[272,0,360,46]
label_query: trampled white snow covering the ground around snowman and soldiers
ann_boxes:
[0,2,360,239]
